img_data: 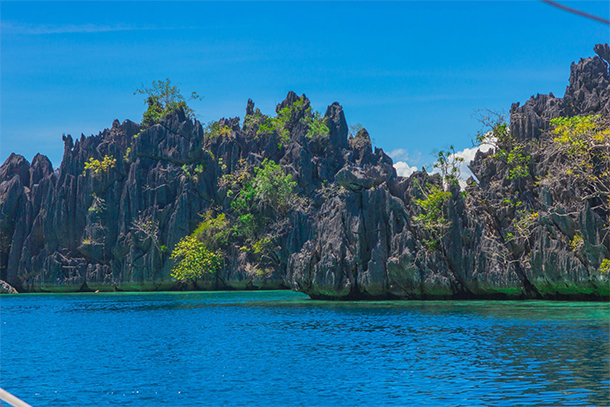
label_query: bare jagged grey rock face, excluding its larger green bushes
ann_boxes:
[0,45,610,299]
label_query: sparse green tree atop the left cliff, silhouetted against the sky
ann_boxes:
[133,78,203,128]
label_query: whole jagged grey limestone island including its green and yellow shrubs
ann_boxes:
[0,44,610,300]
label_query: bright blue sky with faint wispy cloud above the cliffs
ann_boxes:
[0,1,610,171]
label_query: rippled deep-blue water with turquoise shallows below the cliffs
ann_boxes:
[0,291,610,406]
